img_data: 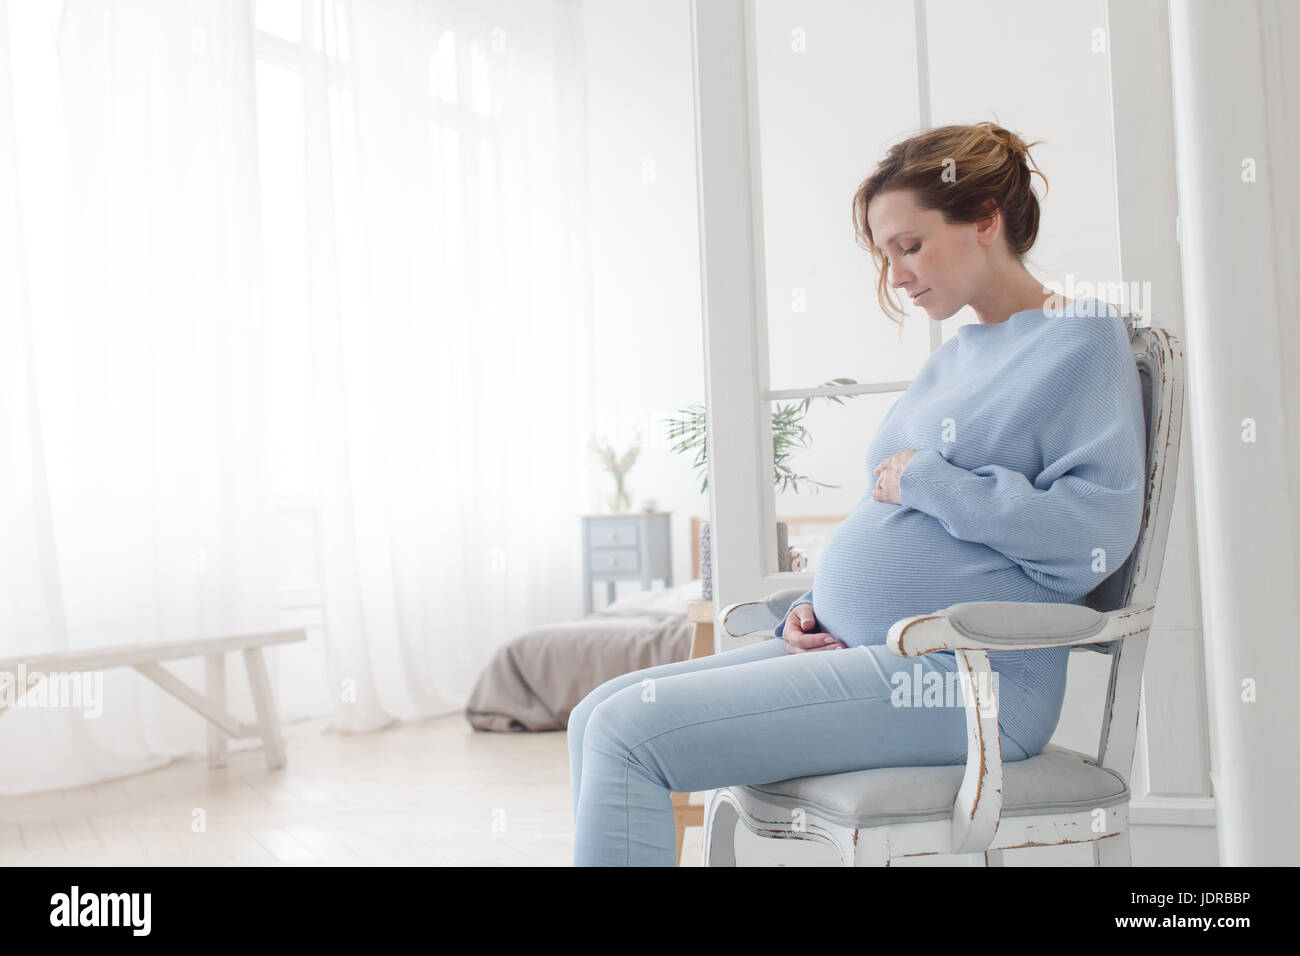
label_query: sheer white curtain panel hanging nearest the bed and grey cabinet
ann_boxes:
[282,0,589,730]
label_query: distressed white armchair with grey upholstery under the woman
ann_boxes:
[703,316,1183,866]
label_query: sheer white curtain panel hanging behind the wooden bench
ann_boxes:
[0,0,278,792]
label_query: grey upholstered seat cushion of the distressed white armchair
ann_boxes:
[731,744,1128,829]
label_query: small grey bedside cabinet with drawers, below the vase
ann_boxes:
[582,511,672,614]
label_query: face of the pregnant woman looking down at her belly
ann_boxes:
[867,190,989,320]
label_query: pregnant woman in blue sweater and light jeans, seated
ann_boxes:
[568,122,1145,866]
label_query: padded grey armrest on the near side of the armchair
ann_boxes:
[889,598,1156,657]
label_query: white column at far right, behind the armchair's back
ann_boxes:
[1170,0,1300,866]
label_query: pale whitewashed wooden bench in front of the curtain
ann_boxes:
[0,628,307,769]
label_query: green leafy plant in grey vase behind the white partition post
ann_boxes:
[667,378,858,598]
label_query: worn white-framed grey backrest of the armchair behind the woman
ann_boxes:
[1084,315,1183,654]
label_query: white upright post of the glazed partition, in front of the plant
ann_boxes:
[690,0,780,621]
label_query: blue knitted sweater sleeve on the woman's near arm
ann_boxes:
[898,317,1145,600]
